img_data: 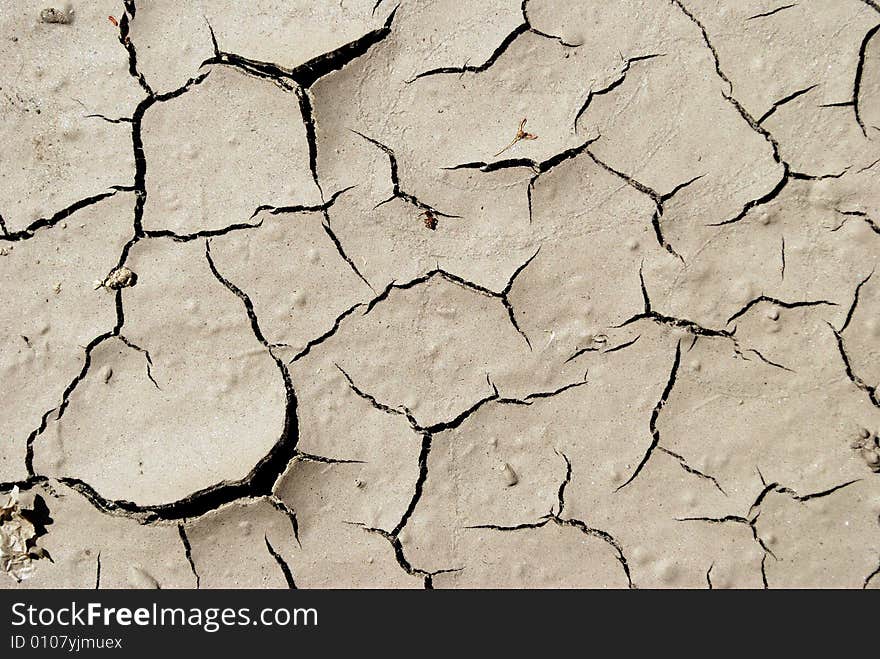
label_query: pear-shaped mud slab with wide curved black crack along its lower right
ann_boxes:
[35,239,286,506]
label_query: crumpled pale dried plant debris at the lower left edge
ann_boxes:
[0,486,52,581]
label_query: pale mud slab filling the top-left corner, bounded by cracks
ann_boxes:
[0,0,144,233]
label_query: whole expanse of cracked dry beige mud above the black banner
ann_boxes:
[0,0,880,588]
